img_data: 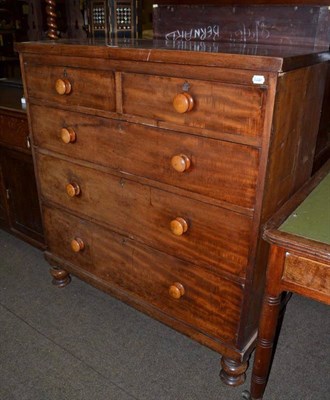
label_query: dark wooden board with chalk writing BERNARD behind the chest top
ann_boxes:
[153,5,330,48]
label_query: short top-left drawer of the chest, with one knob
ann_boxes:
[25,63,116,111]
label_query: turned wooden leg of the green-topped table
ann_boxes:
[251,246,285,400]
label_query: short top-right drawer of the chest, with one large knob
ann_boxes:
[122,73,265,137]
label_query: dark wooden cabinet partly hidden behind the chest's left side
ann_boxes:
[0,81,44,248]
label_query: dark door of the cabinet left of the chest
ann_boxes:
[2,150,42,242]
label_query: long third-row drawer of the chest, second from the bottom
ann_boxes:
[37,154,252,276]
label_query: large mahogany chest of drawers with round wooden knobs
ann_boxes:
[17,41,329,385]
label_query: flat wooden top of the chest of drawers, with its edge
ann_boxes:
[16,39,330,72]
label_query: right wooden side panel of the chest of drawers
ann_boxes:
[264,64,328,219]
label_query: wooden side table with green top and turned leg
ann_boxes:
[251,160,330,400]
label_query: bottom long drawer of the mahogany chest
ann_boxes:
[44,208,243,343]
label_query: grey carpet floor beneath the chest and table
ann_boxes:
[0,231,330,400]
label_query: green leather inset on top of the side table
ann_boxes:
[279,173,330,244]
